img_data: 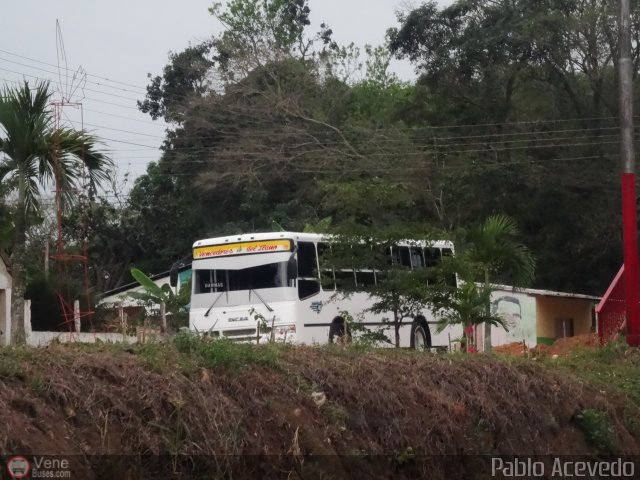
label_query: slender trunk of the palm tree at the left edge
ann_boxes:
[11,171,27,345]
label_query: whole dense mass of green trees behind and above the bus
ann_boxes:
[3,0,640,306]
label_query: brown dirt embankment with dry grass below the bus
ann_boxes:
[0,346,640,479]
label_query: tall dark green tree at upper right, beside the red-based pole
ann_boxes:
[390,0,640,294]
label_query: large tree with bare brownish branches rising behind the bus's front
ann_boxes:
[129,0,410,271]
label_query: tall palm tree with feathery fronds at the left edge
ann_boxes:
[0,81,111,343]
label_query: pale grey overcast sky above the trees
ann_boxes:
[0,0,430,197]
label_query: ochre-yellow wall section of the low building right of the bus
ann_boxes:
[536,296,594,344]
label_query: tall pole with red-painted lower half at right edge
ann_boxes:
[618,0,640,346]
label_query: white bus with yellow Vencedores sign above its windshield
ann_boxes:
[189,232,462,348]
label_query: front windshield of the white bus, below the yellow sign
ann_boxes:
[193,262,287,294]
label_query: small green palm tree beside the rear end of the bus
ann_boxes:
[459,215,535,353]
